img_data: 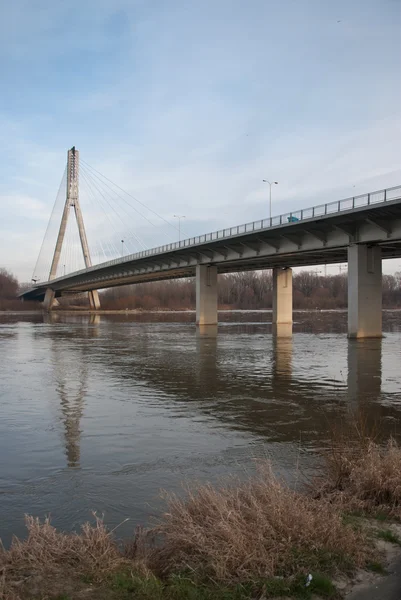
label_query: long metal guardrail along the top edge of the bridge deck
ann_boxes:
[40,185,401,286]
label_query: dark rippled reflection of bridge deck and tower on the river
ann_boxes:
[39,313,398,468]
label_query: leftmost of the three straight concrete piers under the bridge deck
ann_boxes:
[196,265,217,325]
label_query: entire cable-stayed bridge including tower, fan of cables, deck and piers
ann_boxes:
[21,148,401,337]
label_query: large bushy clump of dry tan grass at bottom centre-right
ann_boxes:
[145,464,367,582]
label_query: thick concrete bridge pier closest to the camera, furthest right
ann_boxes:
[348,244,382,338]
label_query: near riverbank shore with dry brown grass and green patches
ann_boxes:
[0,428,401,600]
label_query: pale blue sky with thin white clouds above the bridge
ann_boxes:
[0,0,401,281]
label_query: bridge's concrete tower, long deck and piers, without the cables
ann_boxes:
[21,148,401,338]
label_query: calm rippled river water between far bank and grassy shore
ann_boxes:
[0,311,401,544]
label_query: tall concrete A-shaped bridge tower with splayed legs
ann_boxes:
[43,146,100,311]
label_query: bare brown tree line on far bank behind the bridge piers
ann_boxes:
[0,268,401,310]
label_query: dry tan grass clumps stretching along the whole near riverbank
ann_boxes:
[0,435,401,600]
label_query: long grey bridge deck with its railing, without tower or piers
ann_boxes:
[21,186,401,300]
